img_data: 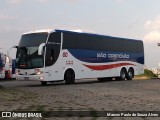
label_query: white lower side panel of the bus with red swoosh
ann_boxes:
[44,46,144,81]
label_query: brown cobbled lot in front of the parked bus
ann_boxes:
[0,79,160,120]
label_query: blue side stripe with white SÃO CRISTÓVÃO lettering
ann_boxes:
[68,49,144,64]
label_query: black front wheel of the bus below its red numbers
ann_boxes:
[64,70,75,84]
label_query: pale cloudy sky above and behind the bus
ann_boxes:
[0,0,160,68]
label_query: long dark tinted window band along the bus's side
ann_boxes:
[63,32,143,52]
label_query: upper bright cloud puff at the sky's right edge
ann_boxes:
[145,16,160,30]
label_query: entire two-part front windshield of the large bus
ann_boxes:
[16,33,48,69]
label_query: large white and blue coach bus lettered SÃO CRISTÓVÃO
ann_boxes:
[15,29,144,85]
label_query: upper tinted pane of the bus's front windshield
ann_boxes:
[19,32,48,47]
